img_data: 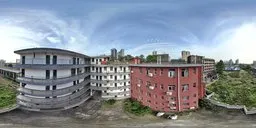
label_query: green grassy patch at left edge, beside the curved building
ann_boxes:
[0,77,16,108]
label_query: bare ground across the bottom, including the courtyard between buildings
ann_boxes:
[0,100,256,128]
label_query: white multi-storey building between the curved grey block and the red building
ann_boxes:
[90,56,130,99]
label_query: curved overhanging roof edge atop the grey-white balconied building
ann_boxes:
[14,47,90,58]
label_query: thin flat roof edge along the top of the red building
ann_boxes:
[130,64,203,68]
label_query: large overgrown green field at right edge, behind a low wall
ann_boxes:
[208,70,256,108]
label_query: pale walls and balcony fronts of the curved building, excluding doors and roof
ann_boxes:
[17,51,90,111]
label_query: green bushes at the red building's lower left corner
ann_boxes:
[124,99,152,116]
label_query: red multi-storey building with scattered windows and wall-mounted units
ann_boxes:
[131,64,205,112]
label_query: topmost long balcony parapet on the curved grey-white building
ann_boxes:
[15,64,90,70]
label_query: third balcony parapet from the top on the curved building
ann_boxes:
[18,80,90,97]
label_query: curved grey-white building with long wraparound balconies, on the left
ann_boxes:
[14,48,92,111]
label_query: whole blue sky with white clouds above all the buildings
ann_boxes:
[0,0,256,63]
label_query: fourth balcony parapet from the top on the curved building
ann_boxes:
[17,86,90,107]
